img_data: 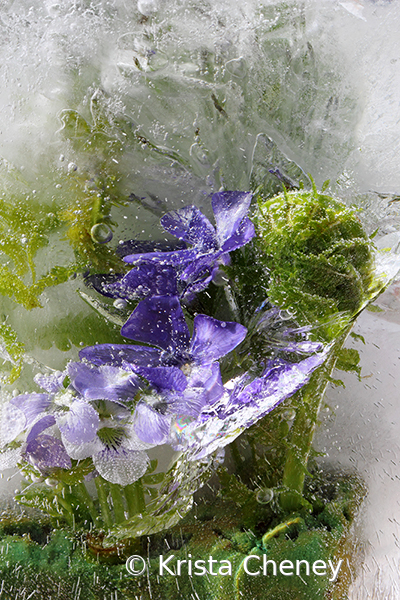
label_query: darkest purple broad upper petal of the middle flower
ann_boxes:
[121,296,190,353]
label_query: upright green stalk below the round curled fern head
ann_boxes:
[280,323,353,513]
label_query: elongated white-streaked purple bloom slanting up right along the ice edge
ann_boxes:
[171,346,330,460]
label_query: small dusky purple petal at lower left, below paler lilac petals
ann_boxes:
[25,434,72,472]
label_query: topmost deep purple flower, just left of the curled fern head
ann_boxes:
[96,192,255,299]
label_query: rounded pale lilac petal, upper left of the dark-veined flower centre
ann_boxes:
[57,400,100,444]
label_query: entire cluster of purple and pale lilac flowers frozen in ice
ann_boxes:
[0,192,327,486]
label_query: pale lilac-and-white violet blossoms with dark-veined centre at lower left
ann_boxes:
[0,363,149,485]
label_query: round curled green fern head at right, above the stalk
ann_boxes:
[257,185,377,340]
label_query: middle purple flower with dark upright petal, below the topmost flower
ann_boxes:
[80,296,247,444]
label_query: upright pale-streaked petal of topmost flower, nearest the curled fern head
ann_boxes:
[211,192,252,247]
